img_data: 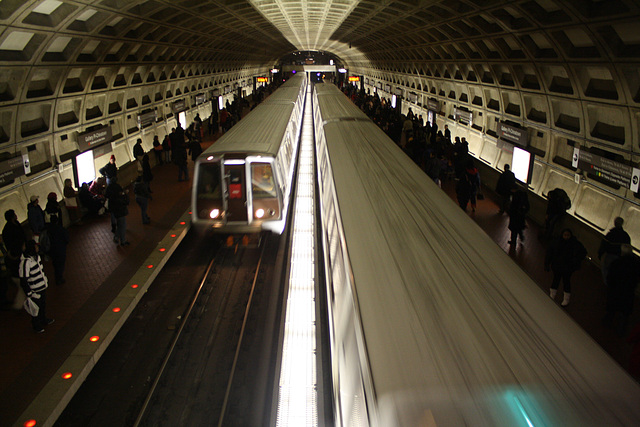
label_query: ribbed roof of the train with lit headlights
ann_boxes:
[203,79,302,156]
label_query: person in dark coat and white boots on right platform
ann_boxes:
[544,228,587,307]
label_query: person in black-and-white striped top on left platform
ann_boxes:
[19,240,54,333]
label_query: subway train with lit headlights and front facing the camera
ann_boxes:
[191,73,307,234]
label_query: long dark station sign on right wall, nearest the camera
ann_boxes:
[571,148,640,193]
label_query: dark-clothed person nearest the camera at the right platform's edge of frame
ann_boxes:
[603,244,640,335]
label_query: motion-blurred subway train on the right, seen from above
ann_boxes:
[313,84,640,427]
